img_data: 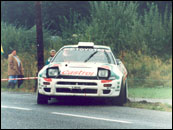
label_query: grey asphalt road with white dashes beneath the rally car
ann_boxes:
[1,92,172,129]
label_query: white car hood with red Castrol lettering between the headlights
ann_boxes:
[38,62,123,79]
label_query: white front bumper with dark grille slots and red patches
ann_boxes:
[38,77,121,97]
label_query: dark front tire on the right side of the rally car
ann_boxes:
[111,80,127,106]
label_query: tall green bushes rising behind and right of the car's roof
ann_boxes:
[61,1,172,59]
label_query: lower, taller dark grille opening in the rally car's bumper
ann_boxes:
[56,88,97,94]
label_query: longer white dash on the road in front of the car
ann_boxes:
[51,112,132,124]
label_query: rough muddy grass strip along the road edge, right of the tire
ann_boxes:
[124,101,172,112]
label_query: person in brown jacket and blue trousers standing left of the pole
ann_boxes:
[7,49,24,88]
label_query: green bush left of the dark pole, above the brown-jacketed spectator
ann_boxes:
[1,22,36,58]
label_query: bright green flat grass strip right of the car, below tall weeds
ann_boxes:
[128,87,172,99]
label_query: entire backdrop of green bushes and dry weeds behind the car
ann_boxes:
[1,1,172,88]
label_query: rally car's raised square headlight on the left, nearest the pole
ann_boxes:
[46,67,59,78]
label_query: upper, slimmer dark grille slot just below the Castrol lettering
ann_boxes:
[57,81,97,86]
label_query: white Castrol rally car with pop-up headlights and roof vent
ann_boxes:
[37,42,127,105]
